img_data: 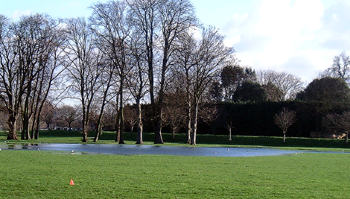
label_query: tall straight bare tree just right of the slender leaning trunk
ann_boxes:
[91,1,131,144]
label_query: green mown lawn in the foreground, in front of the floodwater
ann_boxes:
[0,150,350,199]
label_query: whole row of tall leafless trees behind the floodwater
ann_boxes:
[0,0,232,144]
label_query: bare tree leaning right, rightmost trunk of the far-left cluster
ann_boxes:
[31,16,65,139]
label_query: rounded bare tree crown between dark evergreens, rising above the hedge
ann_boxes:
[258,70,304,100]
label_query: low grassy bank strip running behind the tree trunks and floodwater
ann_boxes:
[0,131,350,152]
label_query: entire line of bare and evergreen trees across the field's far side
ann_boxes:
[0,0,349,144]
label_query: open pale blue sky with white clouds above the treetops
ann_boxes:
[0,0,350,82]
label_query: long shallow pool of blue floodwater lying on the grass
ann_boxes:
[0,144,303,157]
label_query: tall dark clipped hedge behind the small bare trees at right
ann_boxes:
[210,101,350,137]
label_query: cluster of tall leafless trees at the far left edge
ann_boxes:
[0,15,65,139]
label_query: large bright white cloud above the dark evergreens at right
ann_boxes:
[223,0,350,82]
